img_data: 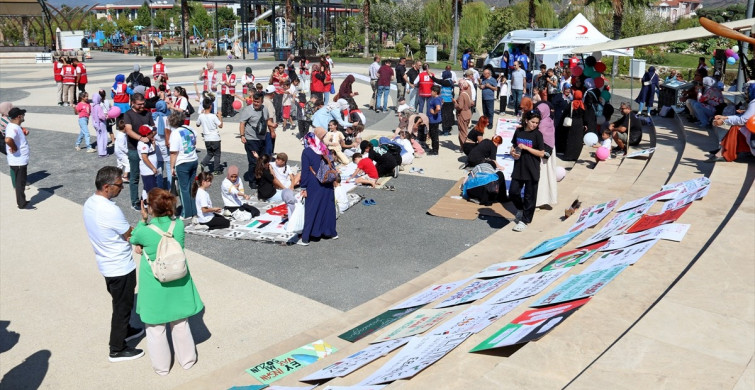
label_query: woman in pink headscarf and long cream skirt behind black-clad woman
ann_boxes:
[535,102,558,207]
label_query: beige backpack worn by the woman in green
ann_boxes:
[144,221,187,283]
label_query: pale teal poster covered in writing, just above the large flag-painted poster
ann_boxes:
[530,265,628,307]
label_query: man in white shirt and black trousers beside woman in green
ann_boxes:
[84,166,144,362]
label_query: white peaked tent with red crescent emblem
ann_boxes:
[535,13,634,56]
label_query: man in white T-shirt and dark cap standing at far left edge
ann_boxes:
[5,107,29,209]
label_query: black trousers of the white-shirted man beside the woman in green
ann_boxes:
[105,270,136,352]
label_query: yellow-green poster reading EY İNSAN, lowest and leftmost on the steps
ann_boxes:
[246,340,337,384]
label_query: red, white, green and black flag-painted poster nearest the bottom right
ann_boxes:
[469,298,590,352]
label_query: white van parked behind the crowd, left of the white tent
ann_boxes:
[485,29,561,72]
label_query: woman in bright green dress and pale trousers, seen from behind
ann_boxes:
[131,188,204,375]
